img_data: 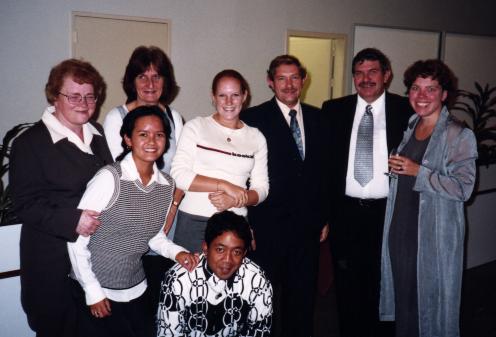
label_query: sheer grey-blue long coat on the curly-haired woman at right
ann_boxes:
[379,107,477,337]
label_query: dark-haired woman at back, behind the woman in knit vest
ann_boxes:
[103,46,184,328]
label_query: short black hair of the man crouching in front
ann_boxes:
[205,211,252,250]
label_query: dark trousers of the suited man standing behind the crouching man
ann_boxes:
[250,232,319,337]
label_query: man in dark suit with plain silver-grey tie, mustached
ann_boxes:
[322,48,413,337]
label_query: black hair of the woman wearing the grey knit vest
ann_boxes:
[115,105,171,169]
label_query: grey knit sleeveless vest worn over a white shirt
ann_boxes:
[81,162,174,289]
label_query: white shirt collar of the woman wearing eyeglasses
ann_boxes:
[41,106,101,154]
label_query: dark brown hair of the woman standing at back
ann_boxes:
[122,46,179,105]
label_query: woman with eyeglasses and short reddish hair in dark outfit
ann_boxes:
[9,59,113,337]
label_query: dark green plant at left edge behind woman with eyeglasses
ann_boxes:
[0,123,32,225]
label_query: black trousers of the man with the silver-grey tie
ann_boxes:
[329,197,394,337]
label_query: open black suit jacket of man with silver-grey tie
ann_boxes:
[321,92,414,220]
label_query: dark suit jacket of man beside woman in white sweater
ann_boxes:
[241,98,323,239]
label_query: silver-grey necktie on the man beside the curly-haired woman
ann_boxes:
[354,105,374,186]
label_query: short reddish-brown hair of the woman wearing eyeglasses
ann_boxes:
[45,59,107,105]
